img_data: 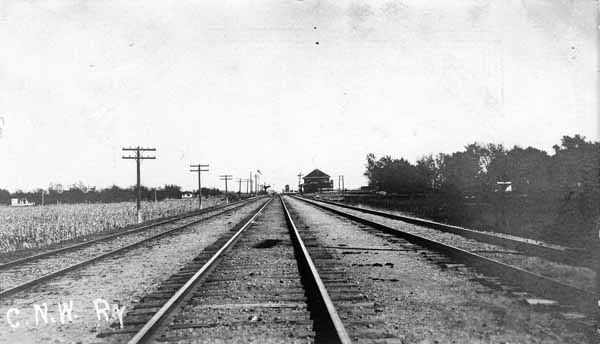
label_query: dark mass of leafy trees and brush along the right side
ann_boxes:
[364,135,600,244]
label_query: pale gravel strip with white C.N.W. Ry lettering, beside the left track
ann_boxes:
[0,200,265,343]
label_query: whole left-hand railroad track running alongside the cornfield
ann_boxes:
[0,199,264,299]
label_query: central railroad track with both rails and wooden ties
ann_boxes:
[99,198,391,344]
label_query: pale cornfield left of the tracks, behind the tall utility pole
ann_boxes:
[0,198,220,252]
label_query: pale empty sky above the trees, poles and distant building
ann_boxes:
[0,0,600,191]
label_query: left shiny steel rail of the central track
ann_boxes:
[128,198,273,344]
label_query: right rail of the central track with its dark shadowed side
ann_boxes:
[279,197,352,344]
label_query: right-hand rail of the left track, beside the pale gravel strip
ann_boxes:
[0,198,262,299]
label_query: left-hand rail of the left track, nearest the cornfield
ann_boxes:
[0,199,258,271]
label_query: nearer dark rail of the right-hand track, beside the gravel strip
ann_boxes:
[295,197,600,314]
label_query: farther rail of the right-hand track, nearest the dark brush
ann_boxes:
[302,198,595,269]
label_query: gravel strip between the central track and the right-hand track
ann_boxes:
[286,197,597,344]
